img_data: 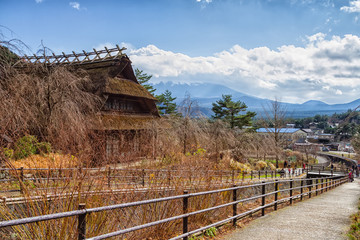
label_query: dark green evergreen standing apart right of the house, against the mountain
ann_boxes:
[212,95,256,128]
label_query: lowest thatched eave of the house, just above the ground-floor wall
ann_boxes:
[95,114,159,130]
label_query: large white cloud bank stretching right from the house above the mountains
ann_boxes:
[127,33,360,102]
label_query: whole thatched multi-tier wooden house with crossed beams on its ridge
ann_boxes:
[14,46,159,161]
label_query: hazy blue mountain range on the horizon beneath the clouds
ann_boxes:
[154,82,360,118]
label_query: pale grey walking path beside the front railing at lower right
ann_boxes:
[223,179,360,240]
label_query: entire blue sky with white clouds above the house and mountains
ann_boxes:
[0,0,360,103]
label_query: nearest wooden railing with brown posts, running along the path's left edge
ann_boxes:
[0,174,348,240]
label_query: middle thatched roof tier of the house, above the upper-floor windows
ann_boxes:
[104,78,156,100]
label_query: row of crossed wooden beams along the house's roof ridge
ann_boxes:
[15,45,126,66]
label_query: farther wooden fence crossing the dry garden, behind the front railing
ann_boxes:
[0,166,344,197]
